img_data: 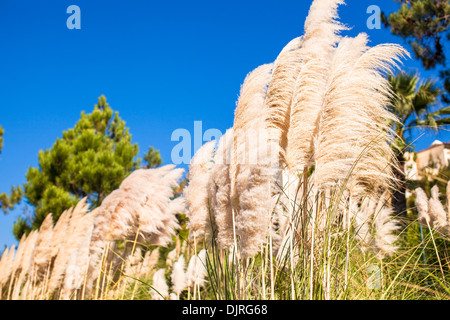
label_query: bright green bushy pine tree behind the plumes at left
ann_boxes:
[10,96,156,238]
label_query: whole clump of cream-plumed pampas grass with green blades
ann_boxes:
[0,0,450,300]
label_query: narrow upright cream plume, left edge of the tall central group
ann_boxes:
[232,64,279,258]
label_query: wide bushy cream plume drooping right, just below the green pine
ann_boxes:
[86,165,185,293]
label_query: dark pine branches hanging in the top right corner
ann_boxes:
[382,0,450,103]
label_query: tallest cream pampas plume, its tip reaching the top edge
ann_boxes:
[286,0,344,173]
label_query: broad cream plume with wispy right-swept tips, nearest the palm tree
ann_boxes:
[314,34,405,197]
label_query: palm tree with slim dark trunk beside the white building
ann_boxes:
[388,72,450,215]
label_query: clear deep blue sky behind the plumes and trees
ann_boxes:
[0,0,448,250]
